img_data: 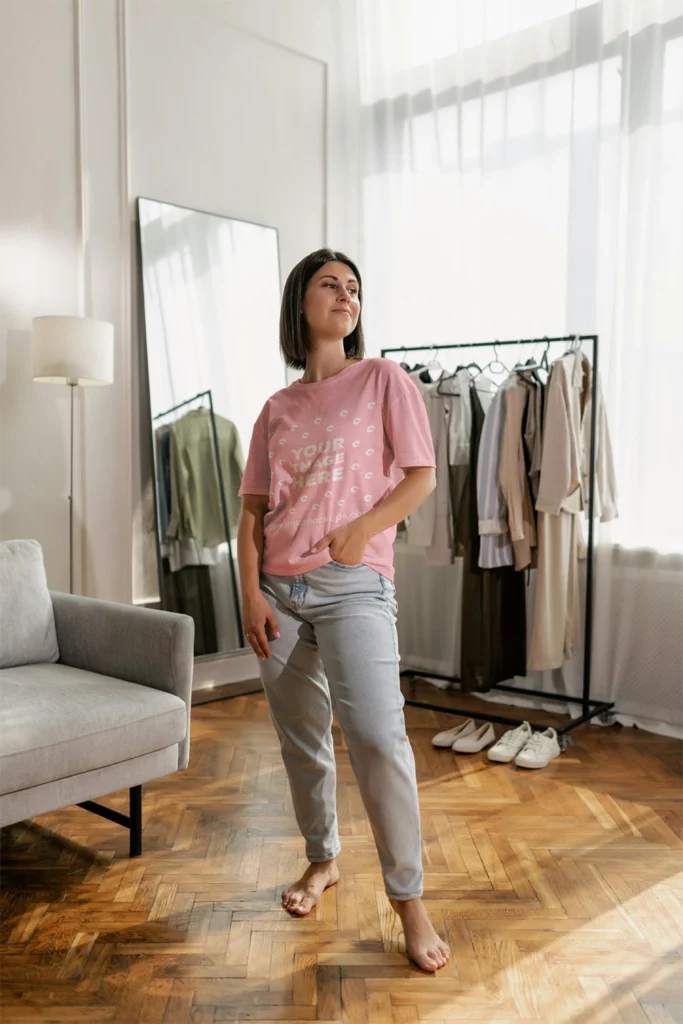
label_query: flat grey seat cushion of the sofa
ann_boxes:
[0,665,187,795]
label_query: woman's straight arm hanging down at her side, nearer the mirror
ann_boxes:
[238,495,280,658]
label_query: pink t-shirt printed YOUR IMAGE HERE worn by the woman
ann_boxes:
[240,358,435,580]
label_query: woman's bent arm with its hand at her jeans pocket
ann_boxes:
[312,466,436,565]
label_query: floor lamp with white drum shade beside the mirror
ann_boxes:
[33,316,114,594]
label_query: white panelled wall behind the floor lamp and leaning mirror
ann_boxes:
[0,0,357,601]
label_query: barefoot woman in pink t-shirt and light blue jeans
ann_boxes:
[238,249,450,971]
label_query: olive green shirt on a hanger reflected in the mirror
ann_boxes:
[168,409,244,548]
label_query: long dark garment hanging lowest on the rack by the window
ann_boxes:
[454,388,526,692]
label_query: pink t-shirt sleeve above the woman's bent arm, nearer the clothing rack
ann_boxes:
[384,364,436,469]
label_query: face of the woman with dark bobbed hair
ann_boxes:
[302,261,360,340]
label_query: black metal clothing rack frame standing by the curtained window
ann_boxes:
[381,334,614,750]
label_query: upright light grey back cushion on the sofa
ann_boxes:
[0,541,59,669]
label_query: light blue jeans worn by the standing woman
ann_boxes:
[259,561,423,900]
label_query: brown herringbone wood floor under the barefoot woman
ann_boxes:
[0,687,683,1024]
